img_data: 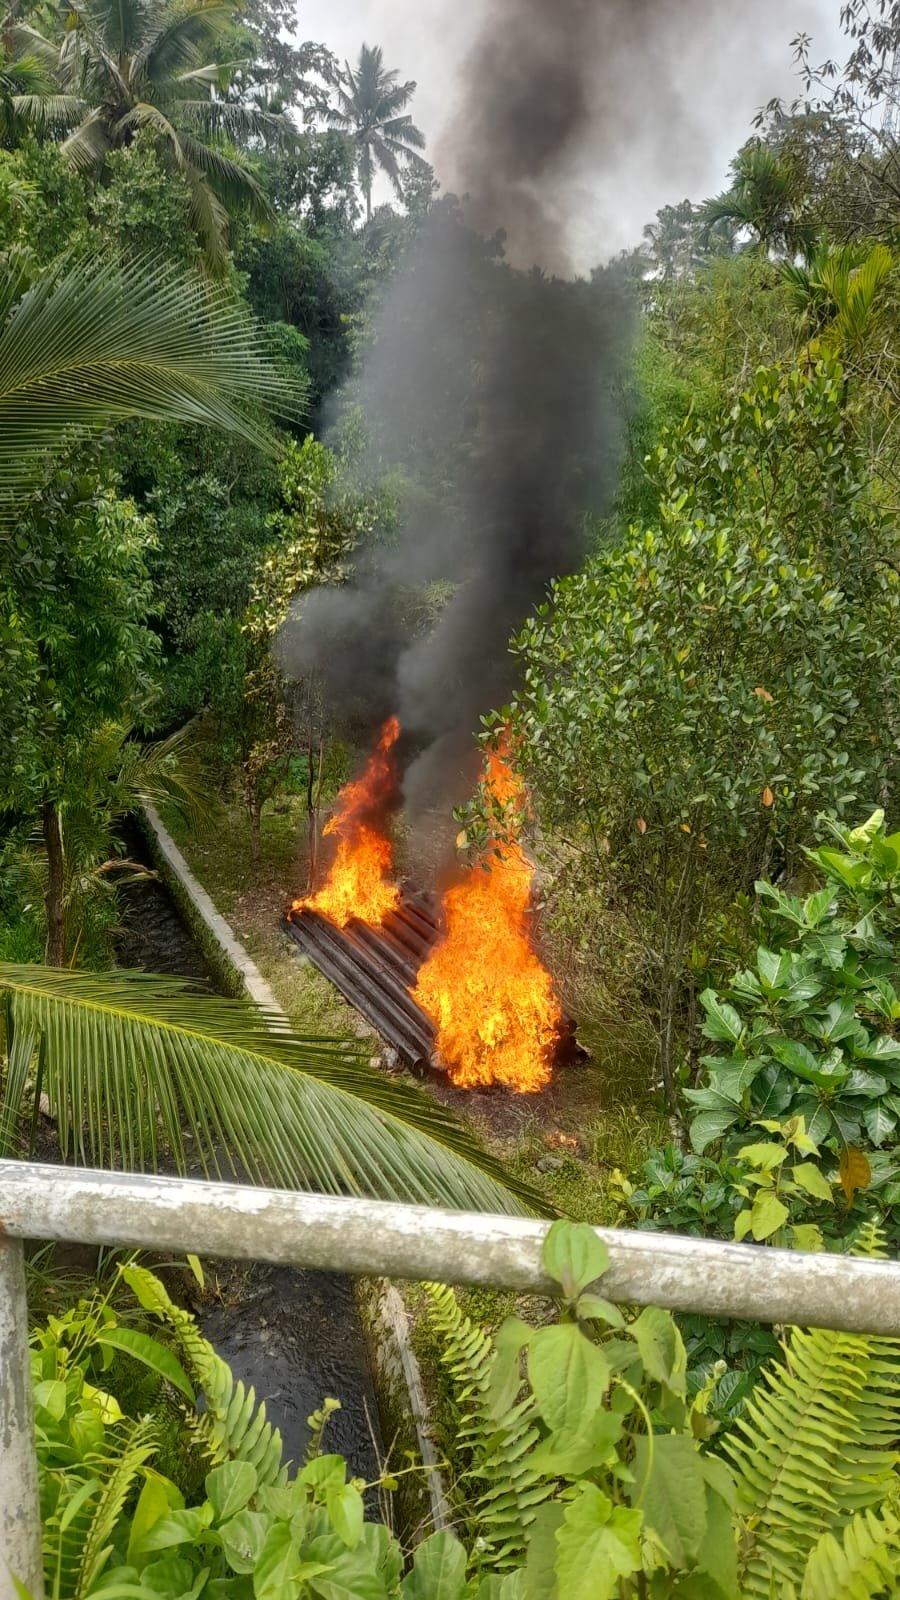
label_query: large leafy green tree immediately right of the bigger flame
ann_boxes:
[500,365,900,1096]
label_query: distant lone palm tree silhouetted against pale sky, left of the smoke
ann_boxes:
[325,45,428,222]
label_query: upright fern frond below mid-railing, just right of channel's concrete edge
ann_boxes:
[424,1283,557,1573]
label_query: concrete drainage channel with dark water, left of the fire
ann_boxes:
[138,806,448,1542]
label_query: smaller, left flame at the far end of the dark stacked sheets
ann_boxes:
[293,717,400,928]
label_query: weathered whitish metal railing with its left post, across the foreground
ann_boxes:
[7,1162,900,1600]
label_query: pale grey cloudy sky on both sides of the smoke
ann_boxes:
[296,0,846,269]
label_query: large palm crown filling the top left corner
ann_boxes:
[13,0,291,270]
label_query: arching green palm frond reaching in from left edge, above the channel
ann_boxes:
[0,261,295,518]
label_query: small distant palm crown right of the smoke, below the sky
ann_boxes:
[701,141,815,256]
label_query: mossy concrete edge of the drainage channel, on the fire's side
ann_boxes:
[144,805,450,1542]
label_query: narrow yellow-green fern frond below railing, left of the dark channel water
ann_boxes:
[122,1266,288,1488]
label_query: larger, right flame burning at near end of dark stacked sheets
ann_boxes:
[413,752,562,1094]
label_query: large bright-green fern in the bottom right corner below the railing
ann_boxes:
[722,1229,900,1600]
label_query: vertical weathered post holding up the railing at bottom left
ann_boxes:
[0,1235,43,1600]
